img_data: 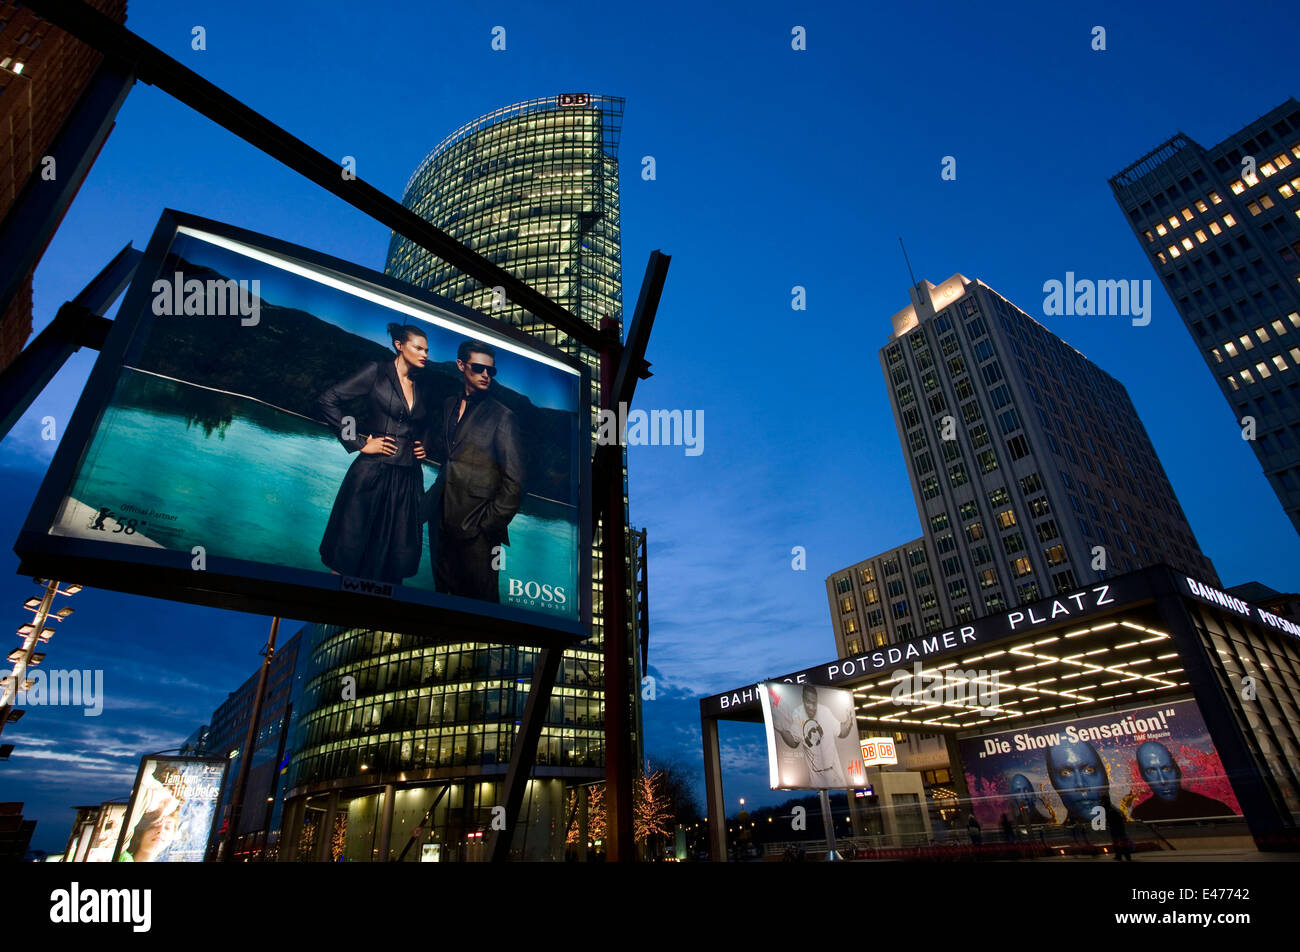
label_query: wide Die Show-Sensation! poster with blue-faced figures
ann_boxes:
[958,701,1242,827]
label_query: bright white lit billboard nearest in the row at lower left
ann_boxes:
[117,756,226,862]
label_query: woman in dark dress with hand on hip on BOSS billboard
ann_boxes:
[317,324,429,584]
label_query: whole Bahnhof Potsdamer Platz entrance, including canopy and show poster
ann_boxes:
[701,566,1300,857]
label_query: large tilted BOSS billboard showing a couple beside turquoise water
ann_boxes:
[14,212,590,642]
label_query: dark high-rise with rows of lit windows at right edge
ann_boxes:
[1110,105,1300,531]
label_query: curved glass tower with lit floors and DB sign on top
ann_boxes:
[282,94,644,861]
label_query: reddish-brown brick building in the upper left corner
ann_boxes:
[0,0,126,369]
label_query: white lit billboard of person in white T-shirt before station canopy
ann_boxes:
[759,681,867,789]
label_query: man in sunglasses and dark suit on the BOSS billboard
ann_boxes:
[429,341,524,602]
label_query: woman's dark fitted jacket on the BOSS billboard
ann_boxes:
[316,360,429,466]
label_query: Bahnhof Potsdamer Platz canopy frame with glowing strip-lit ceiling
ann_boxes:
[699,566,1300,857]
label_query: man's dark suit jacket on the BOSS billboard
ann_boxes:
[426,394,524,545]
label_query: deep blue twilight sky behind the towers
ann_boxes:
[0,0,1300,849]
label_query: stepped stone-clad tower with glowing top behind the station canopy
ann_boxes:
[826,274,1218,795]
